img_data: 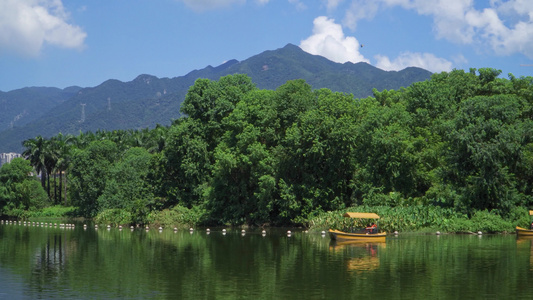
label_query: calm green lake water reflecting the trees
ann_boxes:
[0,224,533,299]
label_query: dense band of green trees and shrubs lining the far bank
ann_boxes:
[0,69,533,232]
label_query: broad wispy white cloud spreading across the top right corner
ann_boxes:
[344,0,533,59]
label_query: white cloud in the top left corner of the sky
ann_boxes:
[0,0,87,56]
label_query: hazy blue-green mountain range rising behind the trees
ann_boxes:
[0,44,431,152]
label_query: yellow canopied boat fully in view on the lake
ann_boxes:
[328,212,387,242]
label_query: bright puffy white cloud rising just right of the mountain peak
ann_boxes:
[300,16,369,63]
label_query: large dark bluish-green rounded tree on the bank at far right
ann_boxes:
[442,95,531,212]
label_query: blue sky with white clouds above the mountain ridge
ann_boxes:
[0,0,533,92]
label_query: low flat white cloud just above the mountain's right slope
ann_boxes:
[374,52,452,73]
